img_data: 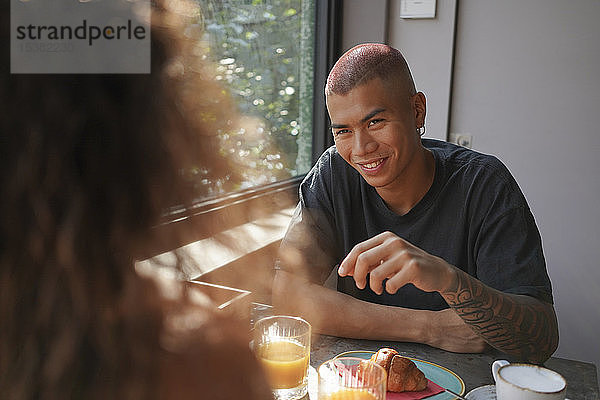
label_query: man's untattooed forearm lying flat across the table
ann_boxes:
[273,271,487,353]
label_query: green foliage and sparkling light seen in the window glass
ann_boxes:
[195,0,315,197]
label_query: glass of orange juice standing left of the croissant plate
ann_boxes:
[254,315,310,400]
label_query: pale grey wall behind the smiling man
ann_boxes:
[344,0,600,372]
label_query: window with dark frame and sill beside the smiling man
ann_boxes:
[156,0,341,252]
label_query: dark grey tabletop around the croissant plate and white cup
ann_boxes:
[306,335,600,400]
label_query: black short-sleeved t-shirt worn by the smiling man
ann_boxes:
[279,139,552,310]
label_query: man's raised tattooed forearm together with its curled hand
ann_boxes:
[339,232,558,363]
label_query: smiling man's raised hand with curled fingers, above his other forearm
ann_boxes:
[338,232,454,294]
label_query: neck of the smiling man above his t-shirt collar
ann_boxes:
[376,147,435,215]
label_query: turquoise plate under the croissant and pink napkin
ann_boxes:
[334,350,465,400]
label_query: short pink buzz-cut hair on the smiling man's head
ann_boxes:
[325,43,416,96]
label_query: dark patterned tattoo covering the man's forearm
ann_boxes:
[441,270,558,363]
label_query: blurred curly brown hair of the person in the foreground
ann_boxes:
[0,0,270,399]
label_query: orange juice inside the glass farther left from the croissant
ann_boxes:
[257,340,310,389]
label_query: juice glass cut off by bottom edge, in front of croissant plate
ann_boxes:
[318,357,387,400]
